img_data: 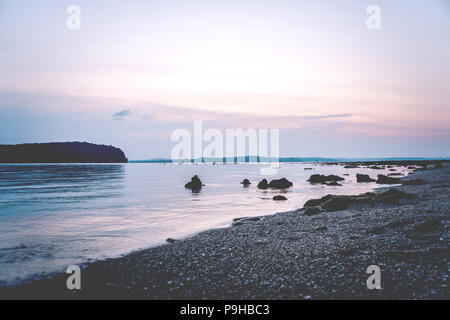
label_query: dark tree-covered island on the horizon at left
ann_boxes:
[0,142,128,163]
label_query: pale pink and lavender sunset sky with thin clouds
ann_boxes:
[0,0,450,160]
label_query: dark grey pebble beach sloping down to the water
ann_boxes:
[0,163,450,299]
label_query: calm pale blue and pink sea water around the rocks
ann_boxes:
[0,163,406,284]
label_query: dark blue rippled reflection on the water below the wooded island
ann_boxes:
[0,164,125,215]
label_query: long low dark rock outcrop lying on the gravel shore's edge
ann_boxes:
[305,189,415,212]
